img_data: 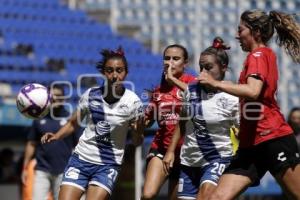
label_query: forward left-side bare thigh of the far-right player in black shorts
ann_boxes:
[209,173,252,200]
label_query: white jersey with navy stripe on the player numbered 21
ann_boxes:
[75,87,143,165]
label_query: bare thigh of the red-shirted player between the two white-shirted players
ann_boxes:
[144,156,168,192]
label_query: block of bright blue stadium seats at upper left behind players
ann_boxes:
[0,0,176,98]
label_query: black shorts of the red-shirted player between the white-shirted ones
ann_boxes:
[146,148,180,180]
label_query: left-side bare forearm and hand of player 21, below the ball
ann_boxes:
[41,111,80,144]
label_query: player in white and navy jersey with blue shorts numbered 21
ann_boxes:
[42,48,144,200]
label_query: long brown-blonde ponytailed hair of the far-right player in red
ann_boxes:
[241,9,300,63]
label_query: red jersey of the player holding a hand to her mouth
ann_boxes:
[145,74,195,152]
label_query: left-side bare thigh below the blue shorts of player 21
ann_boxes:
[58,185,84,200]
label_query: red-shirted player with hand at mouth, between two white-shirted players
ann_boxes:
[142,44,195,200]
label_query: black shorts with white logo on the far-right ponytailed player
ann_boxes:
[224,135,300,186]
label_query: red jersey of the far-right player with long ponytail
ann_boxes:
[239,47,293,148]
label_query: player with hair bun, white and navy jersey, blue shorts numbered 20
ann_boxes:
[163,37,239,200]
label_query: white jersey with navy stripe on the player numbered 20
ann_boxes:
[180,83,239,167]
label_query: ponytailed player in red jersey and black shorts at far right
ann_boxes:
[198,10,300,200]
